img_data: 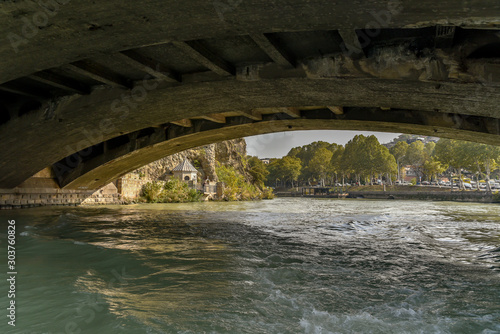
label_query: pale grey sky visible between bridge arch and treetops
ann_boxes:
[245,130,400,158]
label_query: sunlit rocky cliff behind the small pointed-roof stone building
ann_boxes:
[126,139,251,181]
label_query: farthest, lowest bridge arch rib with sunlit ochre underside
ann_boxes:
[53,107,498,190]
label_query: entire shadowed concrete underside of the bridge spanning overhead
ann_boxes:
[0,0,500,189]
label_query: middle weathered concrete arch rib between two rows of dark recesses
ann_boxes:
[0,74,500,187]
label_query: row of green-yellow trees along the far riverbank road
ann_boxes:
[266,135,500,190]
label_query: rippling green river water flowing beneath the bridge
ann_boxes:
[0,198,500,334]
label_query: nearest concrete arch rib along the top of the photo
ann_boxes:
[0,0,500,82]
